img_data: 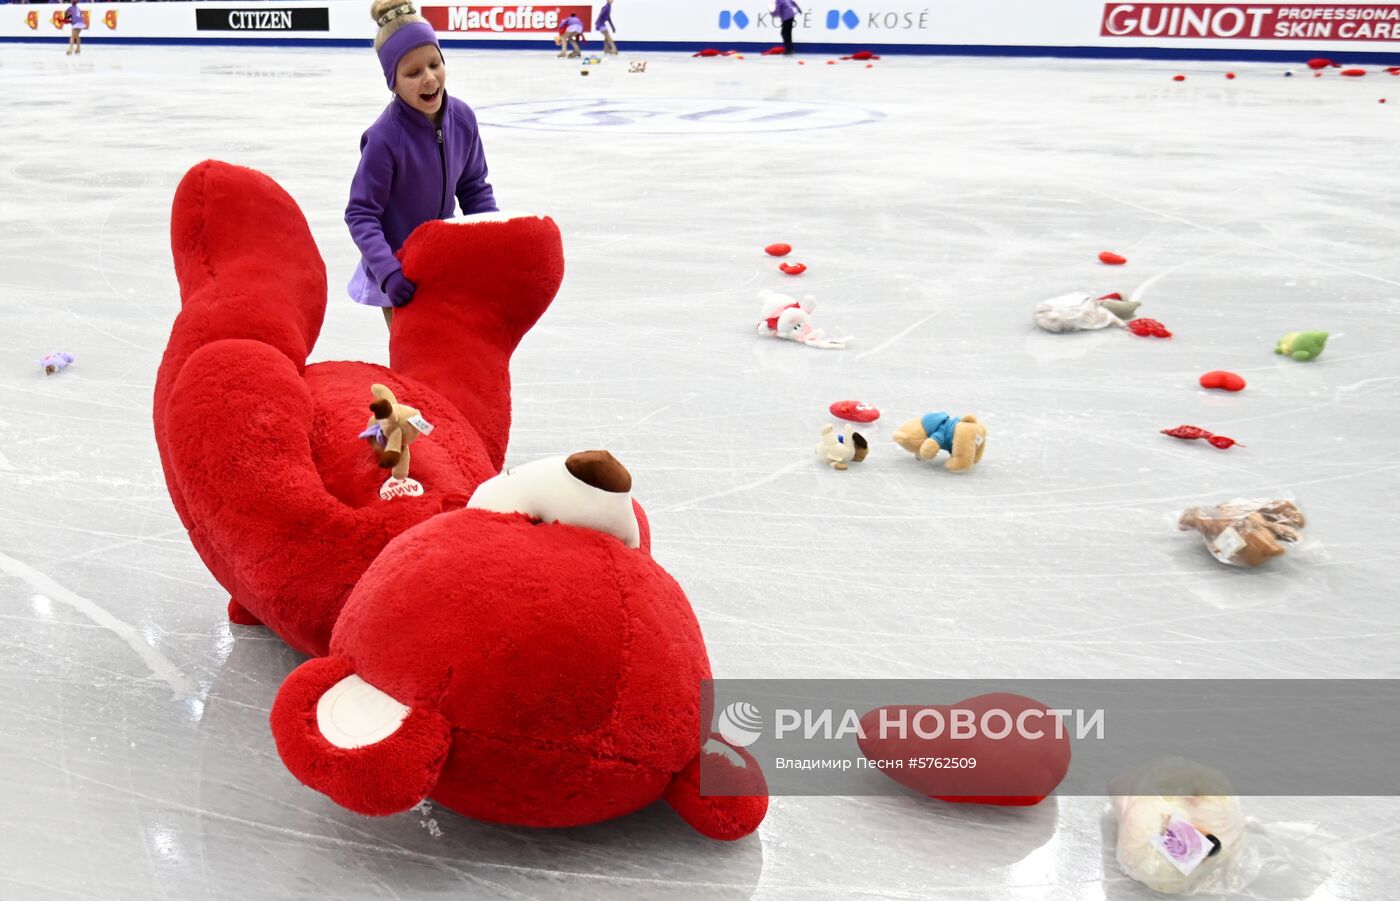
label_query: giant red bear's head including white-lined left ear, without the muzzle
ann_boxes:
[272,509,710,825]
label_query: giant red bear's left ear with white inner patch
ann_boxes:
[272,655,452,816]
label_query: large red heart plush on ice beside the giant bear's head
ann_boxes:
[860,693,1070,807]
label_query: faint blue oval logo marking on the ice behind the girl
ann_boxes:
[475,98,885,134]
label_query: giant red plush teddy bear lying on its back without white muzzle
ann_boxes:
[155,162,767,839]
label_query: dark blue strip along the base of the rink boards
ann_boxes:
[0,32,1400,66]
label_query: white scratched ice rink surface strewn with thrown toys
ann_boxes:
[0,35,1400,901]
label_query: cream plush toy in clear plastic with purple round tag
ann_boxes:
[1109,757,1246,894]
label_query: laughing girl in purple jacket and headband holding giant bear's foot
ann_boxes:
[346,0,496,325]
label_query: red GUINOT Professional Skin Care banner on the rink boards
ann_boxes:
[1099,3,1400,45]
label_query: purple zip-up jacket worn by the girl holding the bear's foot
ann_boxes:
[346,97,496,300]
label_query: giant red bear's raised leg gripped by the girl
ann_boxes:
[389,215,564,469]
